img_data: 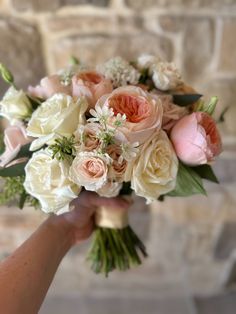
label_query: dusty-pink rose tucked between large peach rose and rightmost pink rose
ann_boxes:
[159,95,188,132]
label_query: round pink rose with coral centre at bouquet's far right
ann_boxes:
[171,112,222,166]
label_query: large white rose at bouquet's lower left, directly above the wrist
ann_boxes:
[24,150,80,214]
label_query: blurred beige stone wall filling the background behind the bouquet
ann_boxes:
[0,0,236,314]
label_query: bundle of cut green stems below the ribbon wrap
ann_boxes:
[87,226,148,277]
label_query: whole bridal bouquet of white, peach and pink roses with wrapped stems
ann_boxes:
[0,55,222,275]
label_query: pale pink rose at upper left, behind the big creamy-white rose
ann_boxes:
[28,74,71,99]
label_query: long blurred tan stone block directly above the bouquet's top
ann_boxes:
[49,33,173,71]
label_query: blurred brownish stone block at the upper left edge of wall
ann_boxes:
[0,17,45,95]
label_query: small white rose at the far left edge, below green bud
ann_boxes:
[0,86,32,124]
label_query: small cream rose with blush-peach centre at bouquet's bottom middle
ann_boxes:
[70,152,110,191]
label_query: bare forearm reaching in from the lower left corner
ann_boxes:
[0,216,73,314]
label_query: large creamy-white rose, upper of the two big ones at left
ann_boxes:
[27,94,87,150]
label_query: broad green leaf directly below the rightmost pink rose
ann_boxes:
[167,163,206,196]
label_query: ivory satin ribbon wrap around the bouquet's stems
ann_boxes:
[95,206,129,229]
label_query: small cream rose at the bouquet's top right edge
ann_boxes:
[150,62,182,91]
